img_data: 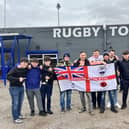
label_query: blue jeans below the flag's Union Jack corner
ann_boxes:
[60,90,72,110]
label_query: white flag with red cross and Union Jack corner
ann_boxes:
[55,64,117,92]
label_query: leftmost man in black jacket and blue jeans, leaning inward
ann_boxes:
[7,58,28,124]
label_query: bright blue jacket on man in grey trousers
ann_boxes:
[26,67,41,89]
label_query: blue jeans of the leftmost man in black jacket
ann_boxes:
[9,87,24,120]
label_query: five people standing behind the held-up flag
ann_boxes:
[60,50,120,115]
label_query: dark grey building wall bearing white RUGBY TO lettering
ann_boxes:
[1,25,129,60]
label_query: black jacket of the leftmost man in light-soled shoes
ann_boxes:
[7,67,27,87]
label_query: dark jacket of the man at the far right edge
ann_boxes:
[117,59,129,80]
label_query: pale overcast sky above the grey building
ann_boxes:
[0,0,129,27]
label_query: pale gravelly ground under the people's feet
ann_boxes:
[0,83,129,129]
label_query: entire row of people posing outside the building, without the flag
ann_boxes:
[7,50,129,123]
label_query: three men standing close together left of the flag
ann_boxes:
[7,57,55,123]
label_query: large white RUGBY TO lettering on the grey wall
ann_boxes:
[53,25,129,38]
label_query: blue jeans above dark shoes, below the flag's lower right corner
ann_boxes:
[100,90,115,110]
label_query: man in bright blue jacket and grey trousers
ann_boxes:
[26,59,46,116]
